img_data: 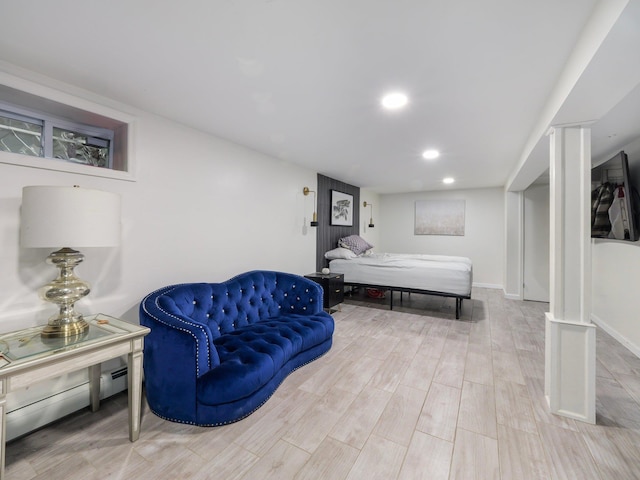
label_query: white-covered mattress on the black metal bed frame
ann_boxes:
[329,253,473,297]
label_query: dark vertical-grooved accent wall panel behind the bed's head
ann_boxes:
[316,174,360,271]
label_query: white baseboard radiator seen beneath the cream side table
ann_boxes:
[6,365,127,441]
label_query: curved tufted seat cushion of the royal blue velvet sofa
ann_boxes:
[197,314,333,405]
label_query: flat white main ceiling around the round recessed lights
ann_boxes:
[0,0,640,193]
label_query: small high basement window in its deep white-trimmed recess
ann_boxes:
[0,81,134,180]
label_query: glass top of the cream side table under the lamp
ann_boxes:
[0,313,140,370]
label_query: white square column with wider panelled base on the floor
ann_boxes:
[545,126,596,423]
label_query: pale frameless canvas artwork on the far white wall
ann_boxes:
[413,200,465,236]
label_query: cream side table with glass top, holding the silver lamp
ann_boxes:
[0,314,150,479]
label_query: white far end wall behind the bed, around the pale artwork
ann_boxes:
[376,188,504,288]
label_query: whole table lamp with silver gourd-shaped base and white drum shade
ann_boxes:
[20,186,120,337]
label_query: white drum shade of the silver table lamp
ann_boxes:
[20,186,121,248]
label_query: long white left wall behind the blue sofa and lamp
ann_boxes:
[0,72,317,332]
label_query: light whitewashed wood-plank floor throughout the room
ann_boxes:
[7,289,640,480]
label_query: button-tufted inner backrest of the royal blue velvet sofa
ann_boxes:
[149,270,322,339]
